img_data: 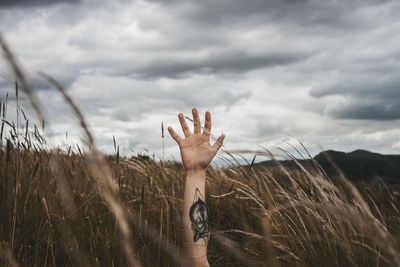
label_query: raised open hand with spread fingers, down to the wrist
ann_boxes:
[168,108,225,171]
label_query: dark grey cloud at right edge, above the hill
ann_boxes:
[310,70,400,120]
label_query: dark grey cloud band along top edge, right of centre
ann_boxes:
[147,0,391,31]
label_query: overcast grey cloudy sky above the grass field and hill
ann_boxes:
[0,0,400,161]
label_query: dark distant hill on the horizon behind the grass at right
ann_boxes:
[257,150,400,183]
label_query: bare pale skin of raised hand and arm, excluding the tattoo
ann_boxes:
[168,108,225,267]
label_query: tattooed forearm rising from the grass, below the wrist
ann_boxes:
[183,169,209,266]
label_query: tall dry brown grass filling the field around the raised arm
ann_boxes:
[0,36,400,266]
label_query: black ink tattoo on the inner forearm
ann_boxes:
[189,188,209,242]
